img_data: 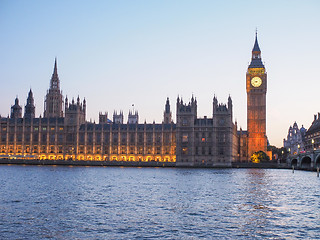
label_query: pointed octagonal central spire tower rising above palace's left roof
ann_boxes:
[43,58,63,118]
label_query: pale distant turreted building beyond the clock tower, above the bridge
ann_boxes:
[283,122,306,154]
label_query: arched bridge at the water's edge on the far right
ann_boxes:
[287,149,320,169]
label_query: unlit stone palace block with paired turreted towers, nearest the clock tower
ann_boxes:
[176,97,236,167]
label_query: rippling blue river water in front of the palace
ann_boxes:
[0,165,320,239]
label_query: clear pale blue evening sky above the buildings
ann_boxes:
[0,0,320,147]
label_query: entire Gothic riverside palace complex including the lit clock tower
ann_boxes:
[0,35,267,167]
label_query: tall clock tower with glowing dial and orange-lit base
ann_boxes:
[246,33,267,158]
